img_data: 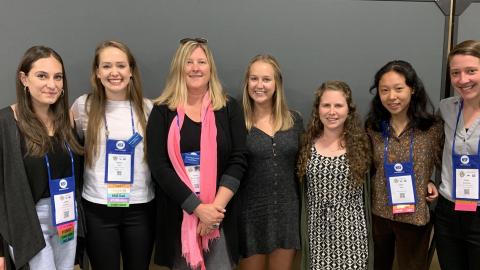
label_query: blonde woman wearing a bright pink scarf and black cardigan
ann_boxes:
[146,38,246,270]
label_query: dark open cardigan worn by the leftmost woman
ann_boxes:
[0,107,85,269]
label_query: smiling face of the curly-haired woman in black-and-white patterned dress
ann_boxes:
[318,89,349,131]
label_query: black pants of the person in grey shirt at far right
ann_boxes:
[435,196,480,270]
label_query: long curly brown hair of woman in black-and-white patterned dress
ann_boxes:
[297,81,371,186]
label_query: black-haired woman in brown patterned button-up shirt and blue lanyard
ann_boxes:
[366,60,443,270]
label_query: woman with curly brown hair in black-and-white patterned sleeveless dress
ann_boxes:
[298,81,372,269]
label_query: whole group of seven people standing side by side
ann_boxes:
[0,38,480,270]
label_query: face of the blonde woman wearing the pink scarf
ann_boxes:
[184,47,210,93]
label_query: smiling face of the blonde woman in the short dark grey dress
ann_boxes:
[248,61,276,105]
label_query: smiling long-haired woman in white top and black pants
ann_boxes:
[71,40,155,270]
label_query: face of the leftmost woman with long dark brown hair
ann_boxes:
[19,56,63,108]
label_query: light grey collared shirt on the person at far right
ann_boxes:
[439,97,480,202]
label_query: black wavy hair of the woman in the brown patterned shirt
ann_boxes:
[365,60,436,132]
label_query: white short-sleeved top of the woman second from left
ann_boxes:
[72,94,155,204]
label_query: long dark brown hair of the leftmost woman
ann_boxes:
[15,46,83,157]
